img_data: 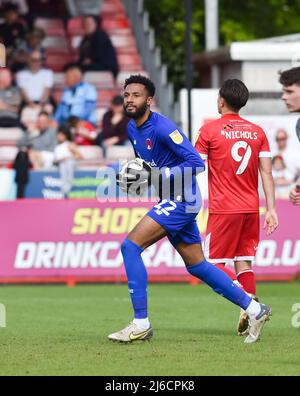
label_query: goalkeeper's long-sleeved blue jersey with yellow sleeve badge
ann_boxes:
[127,112,205,202]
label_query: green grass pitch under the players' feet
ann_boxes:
[0,283,300,376]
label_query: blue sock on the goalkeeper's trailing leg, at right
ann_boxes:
[187,260,252,310]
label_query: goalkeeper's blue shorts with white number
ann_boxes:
[147,199,201,247]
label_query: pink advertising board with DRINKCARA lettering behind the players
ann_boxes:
[0,200,300,285]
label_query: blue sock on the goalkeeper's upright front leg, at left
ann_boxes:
[121,239,148,319]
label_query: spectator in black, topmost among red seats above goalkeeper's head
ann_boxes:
[79,16,119,78]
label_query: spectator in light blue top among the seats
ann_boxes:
[54,64,97,126]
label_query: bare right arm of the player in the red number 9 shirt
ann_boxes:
[259,157,278,235]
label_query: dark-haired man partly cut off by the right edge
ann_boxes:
[279,67,300,205]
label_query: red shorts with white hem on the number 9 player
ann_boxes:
[204,213,259,264]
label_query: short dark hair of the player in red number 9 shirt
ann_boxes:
[219,78,249,111]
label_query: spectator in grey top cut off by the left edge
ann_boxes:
[0,68,21,128]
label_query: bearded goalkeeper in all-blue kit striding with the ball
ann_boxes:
[108,75,271,343]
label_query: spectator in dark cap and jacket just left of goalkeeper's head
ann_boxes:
[98,95,129,150]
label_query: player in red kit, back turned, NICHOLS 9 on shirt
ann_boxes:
[196,79,278,335]
